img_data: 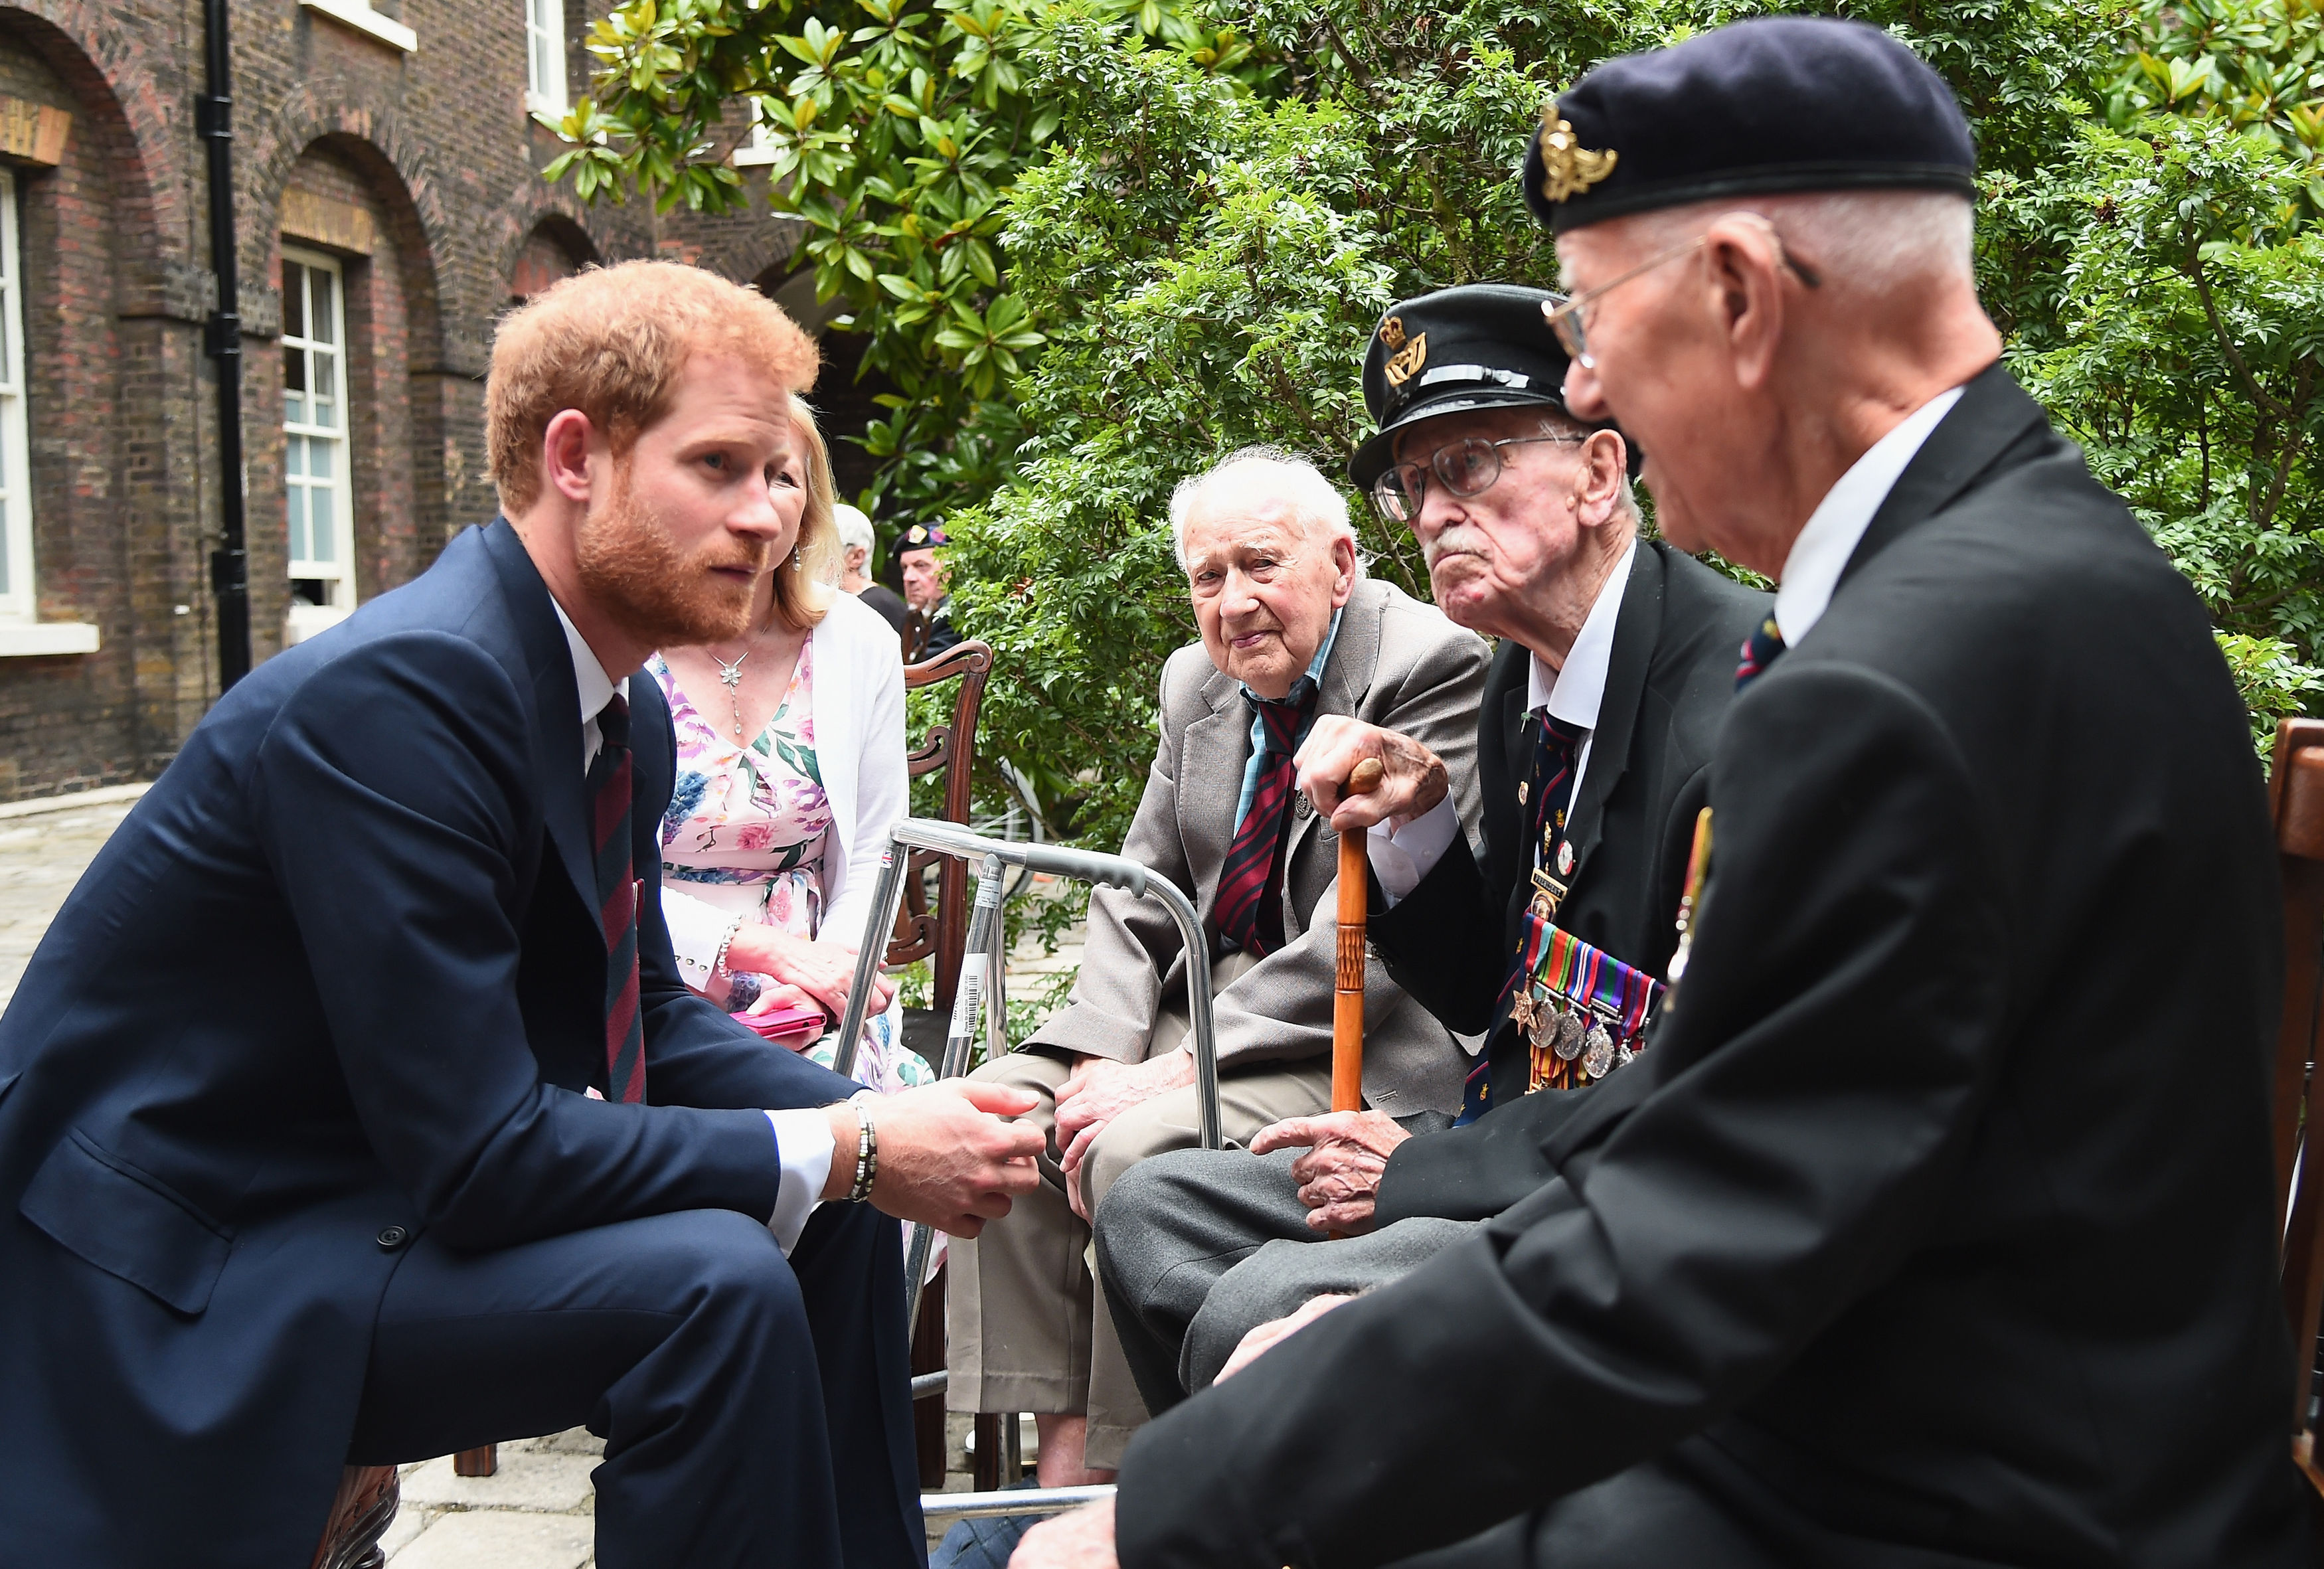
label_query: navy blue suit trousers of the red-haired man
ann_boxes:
[349,1204,928,1569]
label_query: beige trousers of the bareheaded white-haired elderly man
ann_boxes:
[946,990,1332,1469]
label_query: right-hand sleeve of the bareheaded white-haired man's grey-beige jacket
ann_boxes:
[1216,623,1485,1067]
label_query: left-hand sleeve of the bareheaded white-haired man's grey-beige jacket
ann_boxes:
[1025,660,1199,1062]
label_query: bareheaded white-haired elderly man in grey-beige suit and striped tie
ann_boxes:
[951,449,1490,1485]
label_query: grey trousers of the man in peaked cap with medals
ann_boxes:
[1097,1151,1481,1413]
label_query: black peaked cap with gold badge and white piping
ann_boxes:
[1348,284,1639,493]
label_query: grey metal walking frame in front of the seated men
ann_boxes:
[832,818,1225,1518]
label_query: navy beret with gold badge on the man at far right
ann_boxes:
[1525,17,1978,235]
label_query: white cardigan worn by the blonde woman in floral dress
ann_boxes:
[663,590,911,985]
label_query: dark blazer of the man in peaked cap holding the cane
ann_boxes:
[1369,539,1771,1225]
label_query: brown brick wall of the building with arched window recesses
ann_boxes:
[0,0,797,799]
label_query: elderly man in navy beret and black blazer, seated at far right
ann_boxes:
[1018,19,2315,1569]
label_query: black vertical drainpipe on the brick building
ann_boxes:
[193,0,251,693]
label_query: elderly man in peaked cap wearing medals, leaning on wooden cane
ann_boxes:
[1097,284,1769,1411]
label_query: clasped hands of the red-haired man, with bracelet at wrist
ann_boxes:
[823,1078,1044,1236]
